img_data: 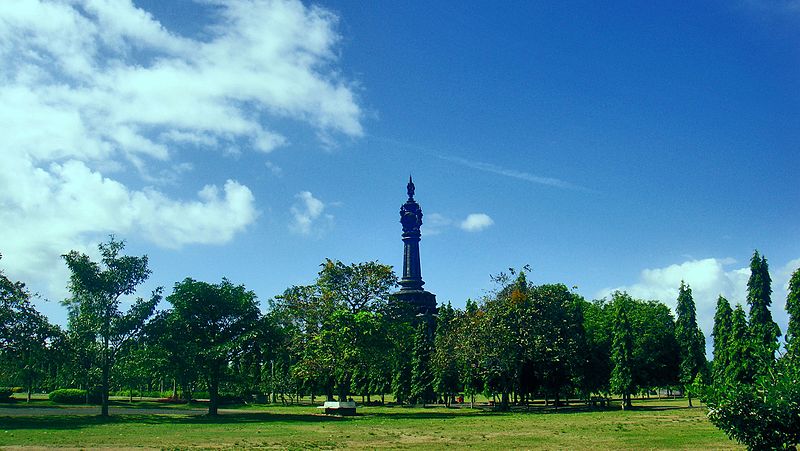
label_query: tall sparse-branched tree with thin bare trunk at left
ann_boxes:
[62,236,161,416]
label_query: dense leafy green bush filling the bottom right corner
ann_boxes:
[706,363,800,449]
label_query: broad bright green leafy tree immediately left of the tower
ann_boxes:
[273,259,397,400]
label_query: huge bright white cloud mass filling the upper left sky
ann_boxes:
[0,0,363,300]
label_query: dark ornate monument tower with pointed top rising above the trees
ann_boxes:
[394,176,436,315]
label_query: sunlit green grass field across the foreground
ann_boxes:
[0,400,741,450]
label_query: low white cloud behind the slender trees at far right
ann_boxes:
[597,258,800,355]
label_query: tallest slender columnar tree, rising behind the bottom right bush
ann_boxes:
[747,251,781,372]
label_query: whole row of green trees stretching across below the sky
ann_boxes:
[0,238,800,448]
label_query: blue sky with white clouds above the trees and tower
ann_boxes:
[0,0,800,354]
